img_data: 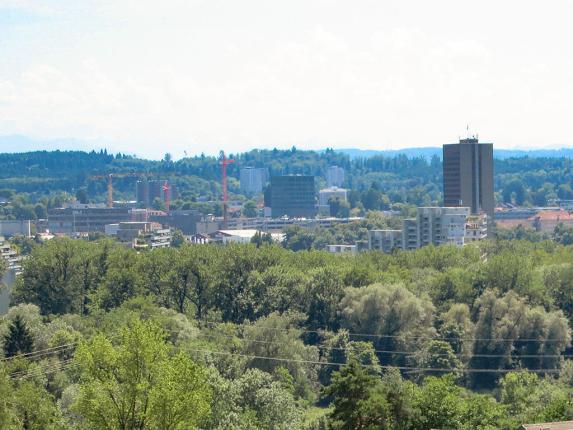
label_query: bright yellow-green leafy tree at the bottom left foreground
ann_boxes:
[75,320,211,430]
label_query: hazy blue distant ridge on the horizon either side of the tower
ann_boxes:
[335,148,573,160]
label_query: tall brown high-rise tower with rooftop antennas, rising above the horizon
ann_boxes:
[443,138,495,220]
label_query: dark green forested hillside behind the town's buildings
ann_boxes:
[0,147,573,209]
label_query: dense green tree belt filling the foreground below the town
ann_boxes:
[0,238,573,430]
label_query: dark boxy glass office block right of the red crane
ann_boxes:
[265,175,316,218]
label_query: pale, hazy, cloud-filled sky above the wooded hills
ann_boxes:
[0,0,573,159]
